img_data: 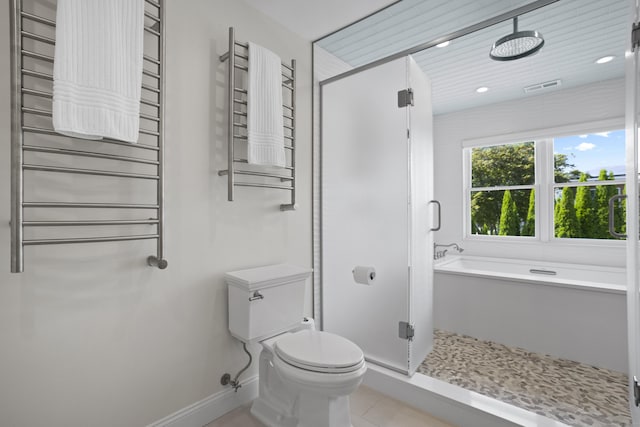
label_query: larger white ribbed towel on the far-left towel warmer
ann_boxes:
[53,0,144,142]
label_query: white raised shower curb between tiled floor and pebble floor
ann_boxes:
[363,363,568,427]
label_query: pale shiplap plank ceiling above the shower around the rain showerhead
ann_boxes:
[318,0,631,114]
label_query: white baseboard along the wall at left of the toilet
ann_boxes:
[147,375,258,427]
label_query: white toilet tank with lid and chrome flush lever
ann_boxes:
[224,264,312,343]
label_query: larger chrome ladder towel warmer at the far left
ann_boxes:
[10,0,167,273]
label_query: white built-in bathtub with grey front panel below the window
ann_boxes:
[433,256,628,372]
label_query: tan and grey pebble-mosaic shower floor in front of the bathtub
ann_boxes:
[419,330,631,427]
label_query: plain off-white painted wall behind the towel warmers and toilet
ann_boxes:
[0,0,312,426]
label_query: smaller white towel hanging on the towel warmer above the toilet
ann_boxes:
[247,42,286,167]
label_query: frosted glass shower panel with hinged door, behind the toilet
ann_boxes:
[321,57,433,373]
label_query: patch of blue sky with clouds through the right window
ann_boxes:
[553,130,625,176]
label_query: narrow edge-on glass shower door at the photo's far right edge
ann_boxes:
[625,0,640,426]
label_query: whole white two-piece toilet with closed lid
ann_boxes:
[225,264,367,427]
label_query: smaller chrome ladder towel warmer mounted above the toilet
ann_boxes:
[218,27,296,211]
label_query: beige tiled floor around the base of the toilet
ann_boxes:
[205,386,453,427]
